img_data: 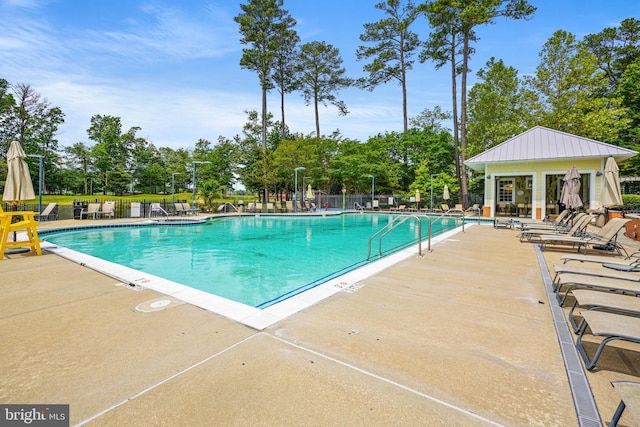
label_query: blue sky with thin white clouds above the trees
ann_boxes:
[0,0,640,149]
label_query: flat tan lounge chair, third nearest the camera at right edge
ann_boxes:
[568,289,640,333]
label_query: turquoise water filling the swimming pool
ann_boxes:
[44,214,457,308]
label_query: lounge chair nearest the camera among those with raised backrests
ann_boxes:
[540,218,630,255]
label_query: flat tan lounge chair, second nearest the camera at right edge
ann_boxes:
[576,310,640,370]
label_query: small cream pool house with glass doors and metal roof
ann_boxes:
[465,126,638,219]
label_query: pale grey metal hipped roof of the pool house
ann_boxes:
[465,126,638,170]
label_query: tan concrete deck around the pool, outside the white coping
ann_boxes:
[0,221,640,426]
